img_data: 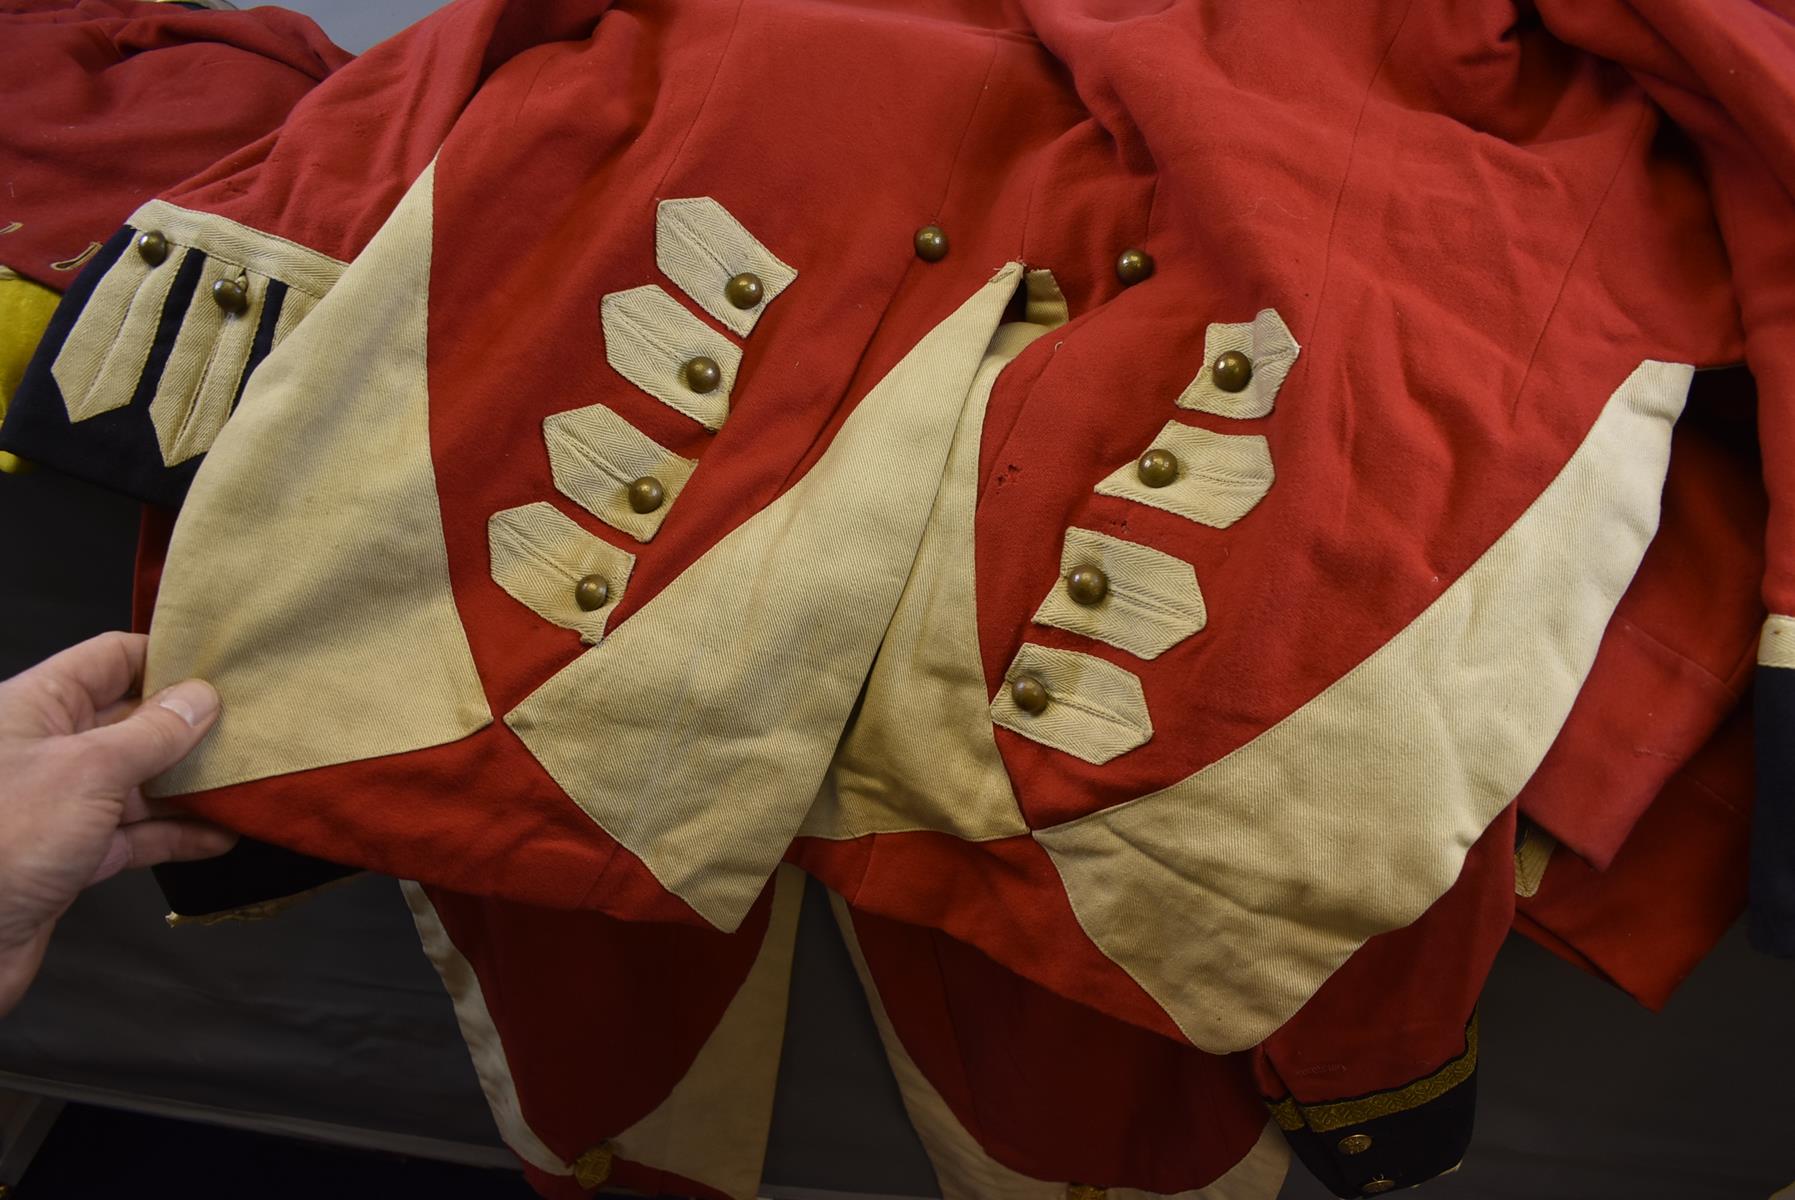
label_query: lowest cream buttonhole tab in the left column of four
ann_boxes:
[486,500,635,646]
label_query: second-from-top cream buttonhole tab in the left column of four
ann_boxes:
[600,283,741,432]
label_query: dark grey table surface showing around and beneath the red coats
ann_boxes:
[0,0,1795,1200]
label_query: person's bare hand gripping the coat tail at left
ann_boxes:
[0,633,237,1015]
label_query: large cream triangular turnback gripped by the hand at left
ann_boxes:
[145,158,492,795]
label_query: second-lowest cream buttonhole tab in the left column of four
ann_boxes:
[542,404,698,542]
